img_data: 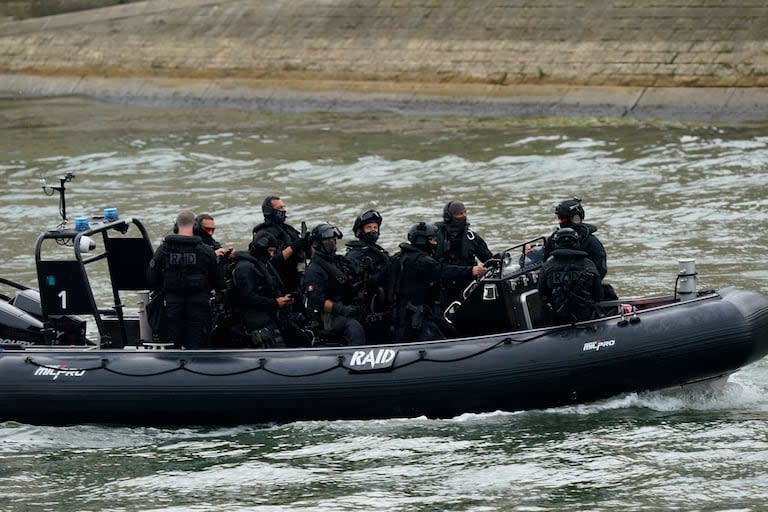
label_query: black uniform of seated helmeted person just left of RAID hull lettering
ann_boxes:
[304,251,365,345]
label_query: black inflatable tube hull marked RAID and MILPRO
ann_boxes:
[0,288,768,425]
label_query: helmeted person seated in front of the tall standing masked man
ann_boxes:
[230,231,307,348]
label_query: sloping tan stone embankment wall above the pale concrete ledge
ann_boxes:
[0,0,768,87]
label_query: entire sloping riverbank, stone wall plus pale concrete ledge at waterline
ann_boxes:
[0,0,768,120]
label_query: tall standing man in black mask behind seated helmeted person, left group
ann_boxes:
[253,196,307,292]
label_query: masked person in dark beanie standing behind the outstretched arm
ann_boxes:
[435,201,493,307]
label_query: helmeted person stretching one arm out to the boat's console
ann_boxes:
[393,222,485,341]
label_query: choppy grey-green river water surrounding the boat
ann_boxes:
[0,100,768,511]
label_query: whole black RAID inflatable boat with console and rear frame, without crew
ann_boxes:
[0,185,768,425]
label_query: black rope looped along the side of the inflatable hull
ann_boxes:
[19,337,530,378]
